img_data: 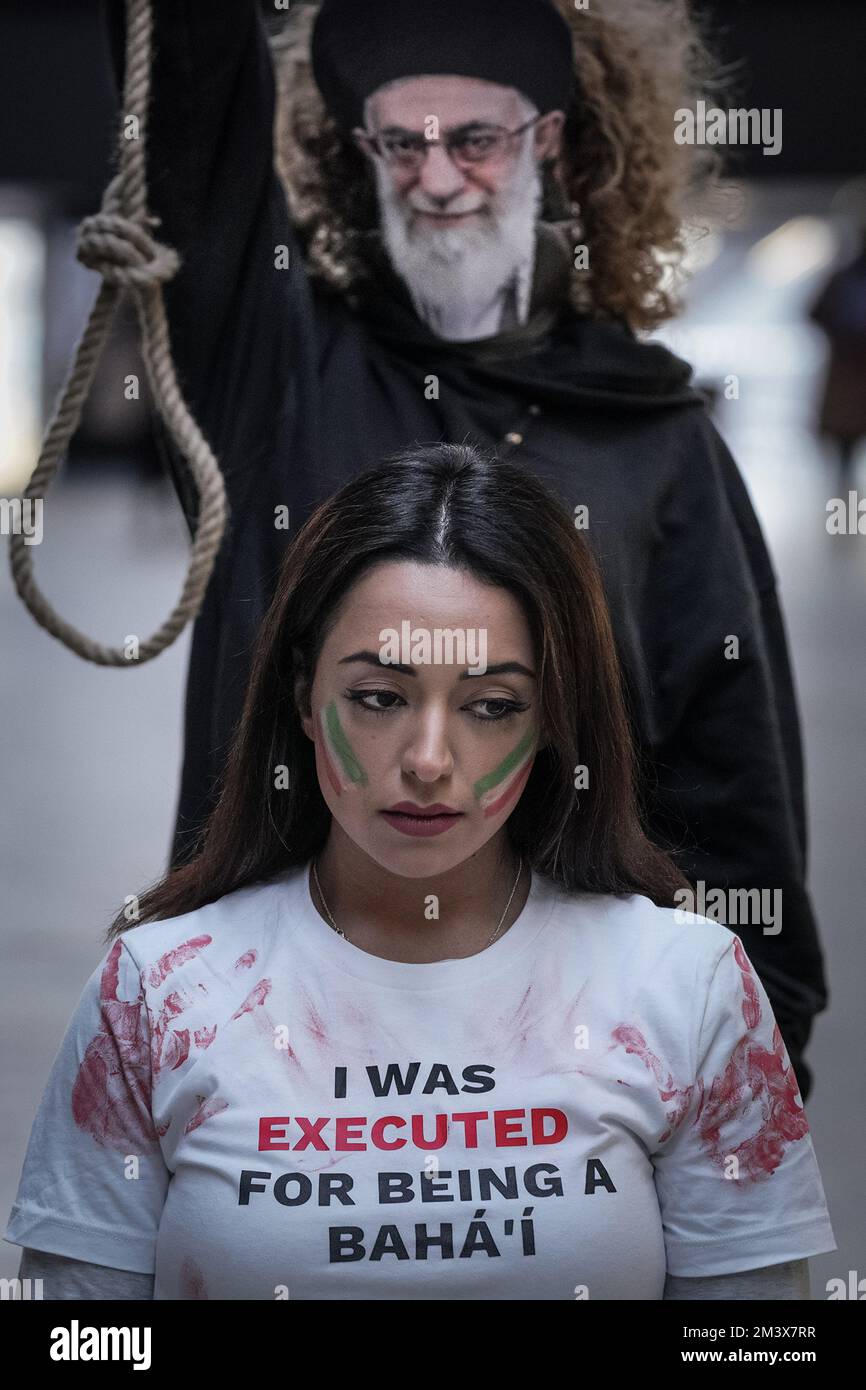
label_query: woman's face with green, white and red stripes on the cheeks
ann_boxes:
[302,562,539,878]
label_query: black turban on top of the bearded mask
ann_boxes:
[311,0,574,131]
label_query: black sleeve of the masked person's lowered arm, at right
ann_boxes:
[646,411,827,1099]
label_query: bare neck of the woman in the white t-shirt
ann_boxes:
[310,821,531,963]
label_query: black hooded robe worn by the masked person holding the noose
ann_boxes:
[103,0,827,1099]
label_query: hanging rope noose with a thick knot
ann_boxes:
[10,0,227,666]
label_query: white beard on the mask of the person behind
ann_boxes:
[374,113,542,341]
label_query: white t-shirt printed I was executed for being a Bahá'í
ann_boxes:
[6,869,837,1300]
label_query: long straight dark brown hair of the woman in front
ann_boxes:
[106,443,688,941]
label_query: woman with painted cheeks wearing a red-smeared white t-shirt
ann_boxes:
[6,445,835,1300]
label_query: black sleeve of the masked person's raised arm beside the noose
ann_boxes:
[101,0,310,530]
